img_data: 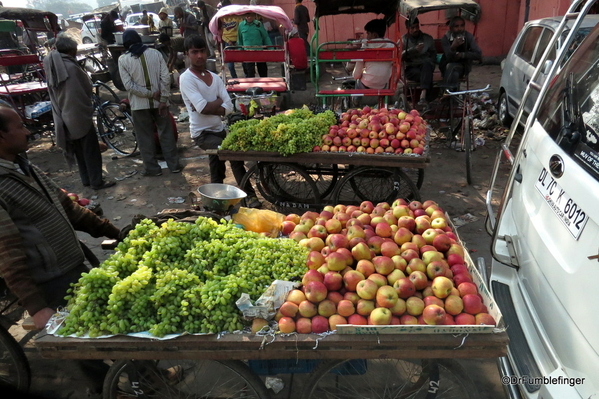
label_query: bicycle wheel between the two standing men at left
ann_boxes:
[96,103,137,156]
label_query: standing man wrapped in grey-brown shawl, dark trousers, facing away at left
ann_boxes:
[44,33,115,190]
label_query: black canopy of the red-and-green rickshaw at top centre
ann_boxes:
[314,0,398,25]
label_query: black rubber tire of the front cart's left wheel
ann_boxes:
[102,360,270,399]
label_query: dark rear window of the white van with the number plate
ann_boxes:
[537,26,599,180]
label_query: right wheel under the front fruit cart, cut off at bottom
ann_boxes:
[302,359,480,399]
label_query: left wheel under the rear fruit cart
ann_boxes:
[258,162,320,208]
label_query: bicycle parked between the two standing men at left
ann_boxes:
[92,81,137,156]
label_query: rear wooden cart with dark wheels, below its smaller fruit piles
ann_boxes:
[218,149,430,209]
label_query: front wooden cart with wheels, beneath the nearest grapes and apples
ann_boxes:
[36,326,508,399]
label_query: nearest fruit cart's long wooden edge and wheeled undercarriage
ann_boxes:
[36,332,508,399]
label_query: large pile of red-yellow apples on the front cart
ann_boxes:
[276,199,495,333]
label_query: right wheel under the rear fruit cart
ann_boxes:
[333,166,420,205]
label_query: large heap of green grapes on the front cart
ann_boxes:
[58,219,310,337]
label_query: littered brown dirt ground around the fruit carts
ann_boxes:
[16,65,507,399]
